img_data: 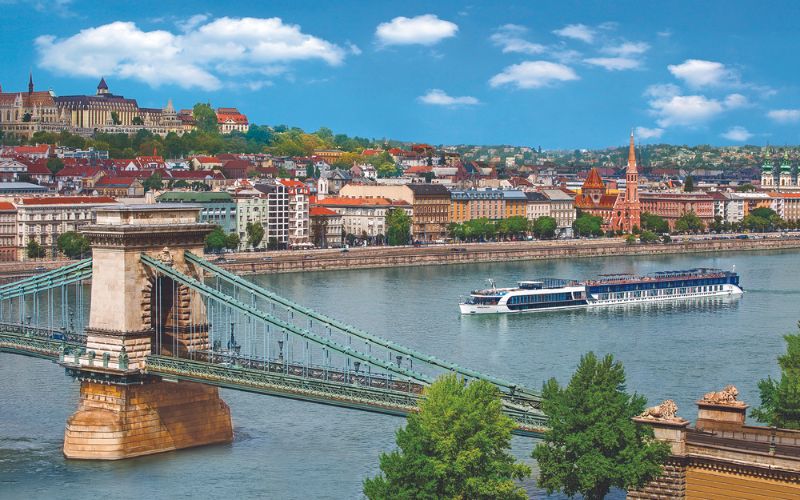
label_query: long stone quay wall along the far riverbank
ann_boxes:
[221,238,800,274]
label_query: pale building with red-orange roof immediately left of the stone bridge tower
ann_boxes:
[15,196,118,260]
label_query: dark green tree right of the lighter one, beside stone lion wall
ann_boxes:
[533,352,669,500]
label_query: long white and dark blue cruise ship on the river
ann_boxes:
[459,268,744,314]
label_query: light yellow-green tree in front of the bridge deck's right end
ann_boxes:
[364,374,530,500]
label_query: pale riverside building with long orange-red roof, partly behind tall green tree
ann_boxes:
[314,197,412,242]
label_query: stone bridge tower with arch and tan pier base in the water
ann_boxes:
[63,204,233,460]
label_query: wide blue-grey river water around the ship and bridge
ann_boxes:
[0,252,800,499]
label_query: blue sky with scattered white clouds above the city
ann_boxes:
[0,0,800,149]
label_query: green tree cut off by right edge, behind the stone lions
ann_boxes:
[751,322,800,429]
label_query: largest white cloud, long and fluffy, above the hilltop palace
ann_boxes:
[35,17,346,90]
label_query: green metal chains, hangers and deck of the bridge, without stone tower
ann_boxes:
[0,251,546,435]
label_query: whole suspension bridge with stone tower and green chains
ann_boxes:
[0,205,546,459]
